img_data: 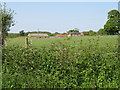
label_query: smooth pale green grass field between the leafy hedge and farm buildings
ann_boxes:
[8,36,118,48]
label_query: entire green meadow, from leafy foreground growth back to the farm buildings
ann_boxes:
[2,35,120,88]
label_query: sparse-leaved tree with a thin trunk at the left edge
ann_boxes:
[0,3,15,46]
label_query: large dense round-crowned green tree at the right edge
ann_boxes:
[104,10,120,35]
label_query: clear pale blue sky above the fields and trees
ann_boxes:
[7,2,118,33]
